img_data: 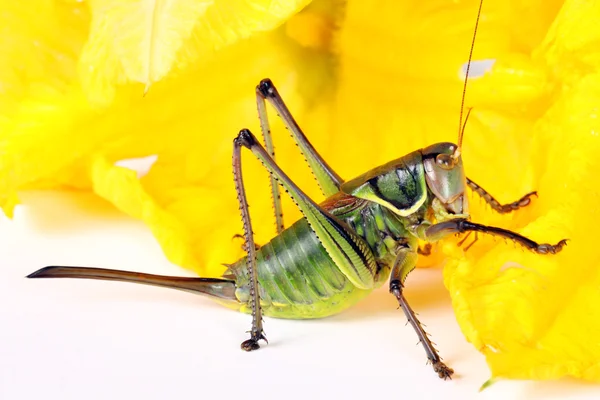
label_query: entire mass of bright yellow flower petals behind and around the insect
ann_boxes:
[0,0,600,380]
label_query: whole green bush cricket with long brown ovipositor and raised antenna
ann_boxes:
[28,0,566,379]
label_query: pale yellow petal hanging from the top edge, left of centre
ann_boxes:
[79,0,308,105]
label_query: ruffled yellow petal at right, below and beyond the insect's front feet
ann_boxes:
[445,71,600,381]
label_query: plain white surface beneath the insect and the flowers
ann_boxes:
[0,193,600,400]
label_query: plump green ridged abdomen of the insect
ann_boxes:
[228,219,370,319]
